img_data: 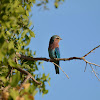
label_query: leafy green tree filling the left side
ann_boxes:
[0,0,63,100]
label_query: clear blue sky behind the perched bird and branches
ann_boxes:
[29,0,100,100]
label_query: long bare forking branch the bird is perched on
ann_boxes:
[16,45,100,78]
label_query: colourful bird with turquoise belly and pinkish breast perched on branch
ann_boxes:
[48,35,62,74]
